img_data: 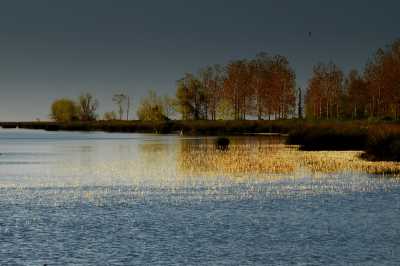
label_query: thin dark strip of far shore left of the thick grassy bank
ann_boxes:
[0,120,305,135]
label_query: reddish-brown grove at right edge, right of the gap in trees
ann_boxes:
[305,40,400,120]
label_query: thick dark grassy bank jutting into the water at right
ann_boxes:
[287,122,400,161]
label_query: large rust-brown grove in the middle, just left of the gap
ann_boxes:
[176,53,296,120]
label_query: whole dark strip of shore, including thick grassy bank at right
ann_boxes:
[0,119,400,161]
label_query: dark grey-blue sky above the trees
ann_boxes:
[0,0,400,121]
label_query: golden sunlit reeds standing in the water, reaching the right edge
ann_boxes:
[177,145,400,176]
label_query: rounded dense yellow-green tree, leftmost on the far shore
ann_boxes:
[50,98,78,123]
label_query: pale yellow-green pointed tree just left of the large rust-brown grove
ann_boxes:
[137,90,168,121]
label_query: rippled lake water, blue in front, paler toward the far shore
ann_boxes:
[0,130,400,265]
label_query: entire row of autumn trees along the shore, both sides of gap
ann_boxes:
[51,40,400,122]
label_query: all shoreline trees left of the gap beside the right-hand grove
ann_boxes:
[51,53,296,122]
